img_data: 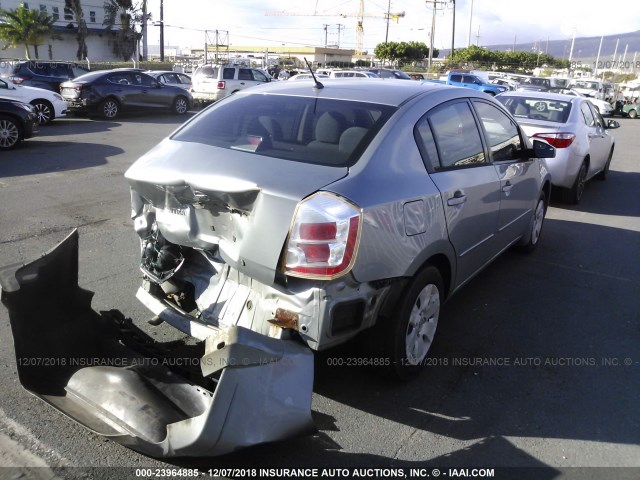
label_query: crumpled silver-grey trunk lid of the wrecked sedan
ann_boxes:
[125,139,347,285]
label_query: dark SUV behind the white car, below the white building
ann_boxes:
[11,60,89,93]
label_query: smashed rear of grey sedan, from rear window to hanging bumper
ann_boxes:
[0,86,394,457]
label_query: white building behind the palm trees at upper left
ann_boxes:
[0,0,122,62]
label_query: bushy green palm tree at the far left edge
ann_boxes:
[0,4,54,60]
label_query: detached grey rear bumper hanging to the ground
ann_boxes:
[0,231,314,457]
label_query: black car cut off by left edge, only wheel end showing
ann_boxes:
[0,98,38,150]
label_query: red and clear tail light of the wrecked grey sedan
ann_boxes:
[284,192,362,280]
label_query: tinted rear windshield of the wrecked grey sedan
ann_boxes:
[172,95,395,167]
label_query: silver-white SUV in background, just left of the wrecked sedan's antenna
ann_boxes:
[191,65,271,104]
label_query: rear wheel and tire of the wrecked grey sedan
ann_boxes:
[376,265,444,380]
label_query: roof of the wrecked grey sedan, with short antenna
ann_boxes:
[234,78,458,107]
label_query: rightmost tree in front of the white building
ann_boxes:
[103,0,142,60]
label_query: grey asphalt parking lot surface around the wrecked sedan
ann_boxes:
[0,111,640,479]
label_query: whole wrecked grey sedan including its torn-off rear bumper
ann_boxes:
[0,79,554,457]
